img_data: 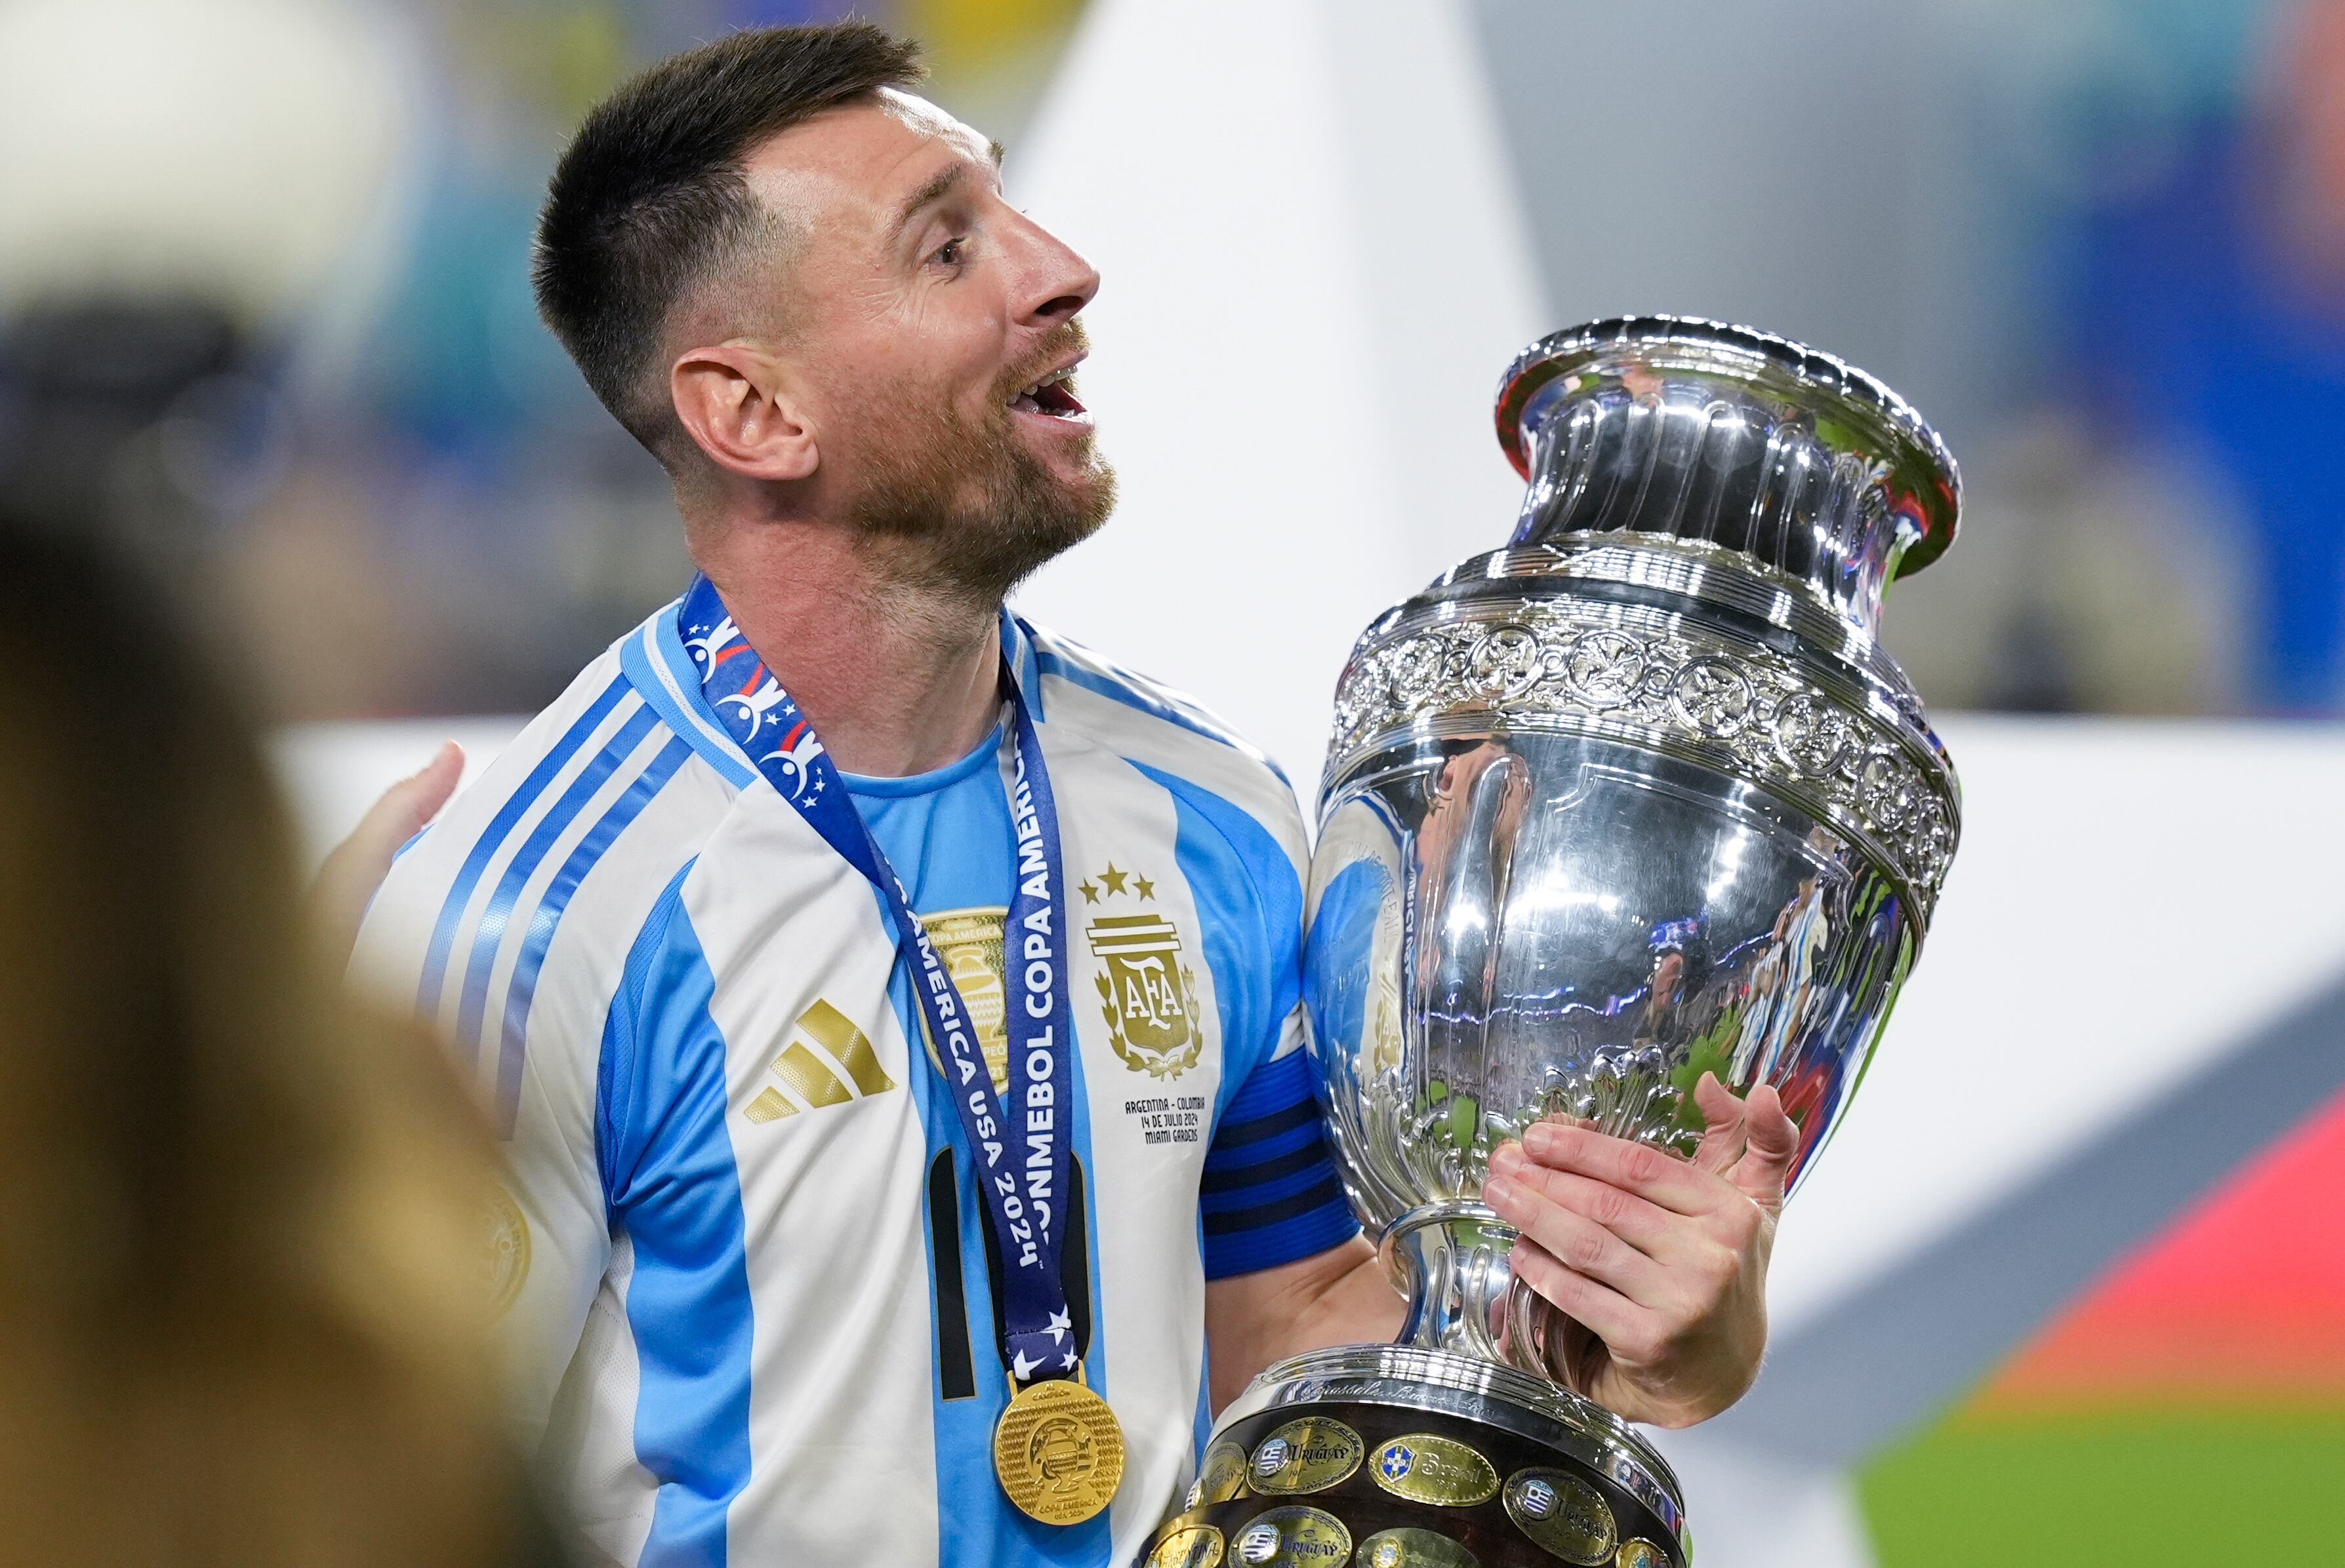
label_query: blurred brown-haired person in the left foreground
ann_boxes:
[0,523,546,1568]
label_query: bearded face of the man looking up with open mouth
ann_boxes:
[748,91,1114,600]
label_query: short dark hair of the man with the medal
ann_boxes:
[533,21,924,462]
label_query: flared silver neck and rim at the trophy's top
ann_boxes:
[1496,316,1963,633]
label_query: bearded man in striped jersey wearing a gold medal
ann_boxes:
[342,24,1794,1563]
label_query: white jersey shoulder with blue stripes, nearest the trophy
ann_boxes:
[1020,621,1309,877]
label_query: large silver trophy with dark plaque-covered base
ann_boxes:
[1149,316,1961,1568]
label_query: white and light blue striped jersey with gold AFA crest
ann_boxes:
[354,605,1355,1568]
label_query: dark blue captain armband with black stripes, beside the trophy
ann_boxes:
[1198,1050,1360,1279]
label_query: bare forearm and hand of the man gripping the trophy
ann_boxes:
[1206,1074,1799,1428]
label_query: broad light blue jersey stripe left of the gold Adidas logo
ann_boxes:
[596,867,755,1568]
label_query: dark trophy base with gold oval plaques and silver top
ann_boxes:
[1139,1345,1691,1568]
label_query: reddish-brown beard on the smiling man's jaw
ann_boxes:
[849,323,1116,607]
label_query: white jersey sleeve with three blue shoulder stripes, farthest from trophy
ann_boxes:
[350,654,734,1449]
